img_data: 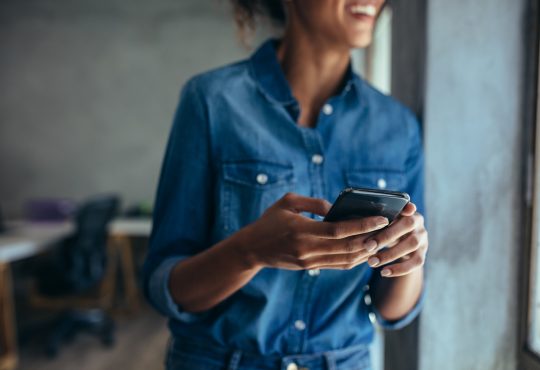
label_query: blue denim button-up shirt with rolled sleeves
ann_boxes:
[144,39,424,355]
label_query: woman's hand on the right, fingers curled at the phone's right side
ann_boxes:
[368,203,428,277]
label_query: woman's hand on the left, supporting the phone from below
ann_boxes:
[237,193,388,270]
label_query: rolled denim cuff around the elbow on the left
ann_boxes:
[148,257,208,322]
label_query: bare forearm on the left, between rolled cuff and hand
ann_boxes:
[169,233,261,312]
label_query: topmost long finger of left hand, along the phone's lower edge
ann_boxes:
[304,216,388,239]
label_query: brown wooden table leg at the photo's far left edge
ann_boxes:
[0,263,18,370]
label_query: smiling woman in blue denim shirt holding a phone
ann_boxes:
[145,0,428,370]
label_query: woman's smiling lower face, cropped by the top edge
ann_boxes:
[285,0,385,48]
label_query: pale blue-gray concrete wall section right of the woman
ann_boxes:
[420,0,525,370]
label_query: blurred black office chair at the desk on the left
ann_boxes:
[30,195,120,357]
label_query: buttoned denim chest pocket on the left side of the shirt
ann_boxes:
[220,161,296,234]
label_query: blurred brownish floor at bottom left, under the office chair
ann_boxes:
[19,306,169,370]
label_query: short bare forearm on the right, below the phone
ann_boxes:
[372,268,424,321]
